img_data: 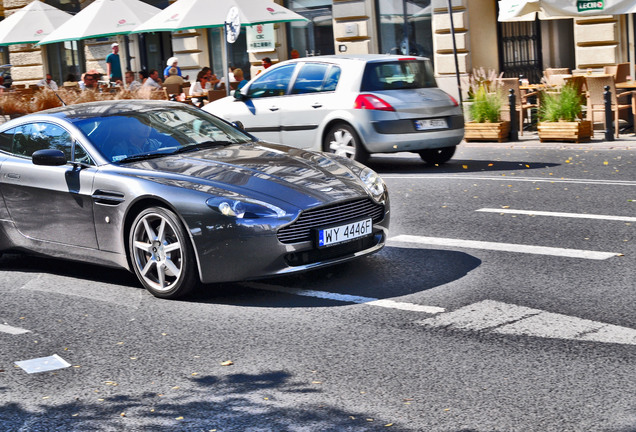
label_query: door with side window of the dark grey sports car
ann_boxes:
[0,122,97,248]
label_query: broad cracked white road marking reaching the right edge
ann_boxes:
[418,300,636,345]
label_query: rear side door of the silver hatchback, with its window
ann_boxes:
[279,62,340,150]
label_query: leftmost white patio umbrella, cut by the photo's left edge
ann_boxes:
[0,0,73,45]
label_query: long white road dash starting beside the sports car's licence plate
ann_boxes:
[389,234,620,260]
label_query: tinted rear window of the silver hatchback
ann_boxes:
[360,60,437,91]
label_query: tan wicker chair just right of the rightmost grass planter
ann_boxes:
[585,75,633,138]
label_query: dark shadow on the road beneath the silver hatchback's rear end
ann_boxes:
[367,157,561,174]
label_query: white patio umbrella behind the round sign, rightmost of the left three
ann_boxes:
[133,0,307,33]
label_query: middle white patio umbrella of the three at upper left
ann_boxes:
[40,0,161,45]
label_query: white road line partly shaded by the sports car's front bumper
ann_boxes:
[245,282,446,314]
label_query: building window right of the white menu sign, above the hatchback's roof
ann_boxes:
[285,0,335,57]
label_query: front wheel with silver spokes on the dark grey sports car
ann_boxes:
[128,207,199,299]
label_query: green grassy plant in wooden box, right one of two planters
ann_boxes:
[537,84,592,143]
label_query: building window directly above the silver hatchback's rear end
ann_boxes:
[376,0,433,60]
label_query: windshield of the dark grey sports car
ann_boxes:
[74,106,253,162]
